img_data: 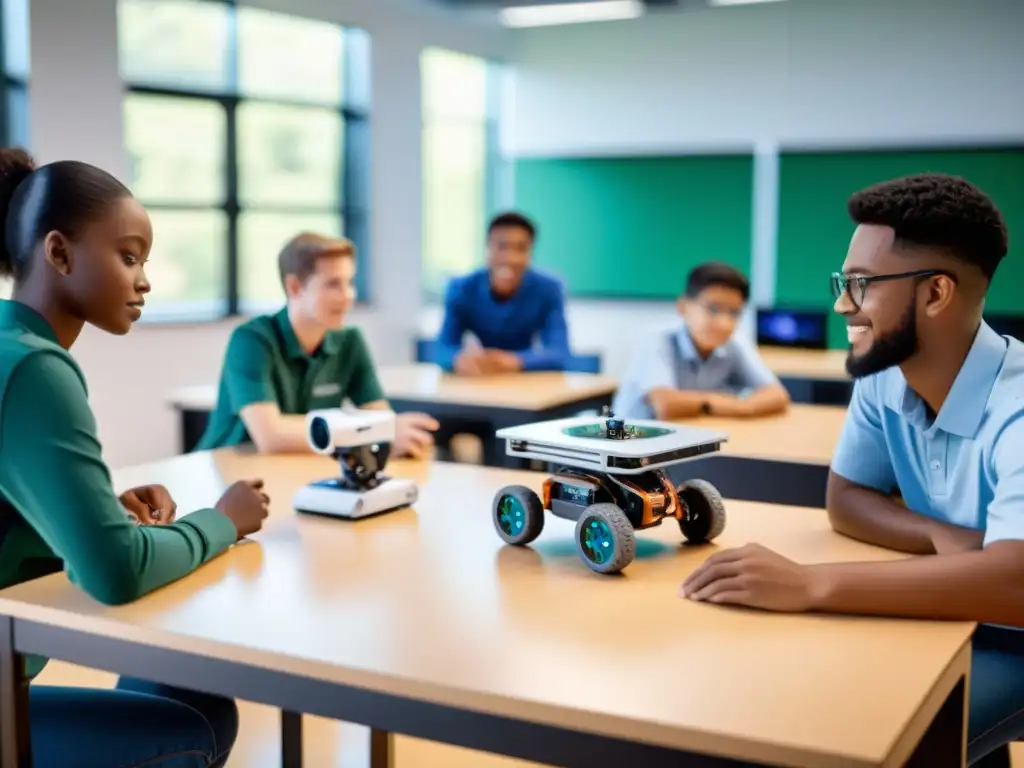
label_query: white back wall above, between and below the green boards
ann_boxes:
[501,0,1024,374]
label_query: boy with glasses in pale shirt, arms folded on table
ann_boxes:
[612,261,790,420]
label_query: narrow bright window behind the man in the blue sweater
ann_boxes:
[420,48,501,300]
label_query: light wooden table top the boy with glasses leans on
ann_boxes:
[680,402,846,466]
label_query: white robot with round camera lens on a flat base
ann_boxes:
[293,408,419,518]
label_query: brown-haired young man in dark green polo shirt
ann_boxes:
[196,232,437,458]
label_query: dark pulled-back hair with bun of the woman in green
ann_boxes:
[0,147,131,282]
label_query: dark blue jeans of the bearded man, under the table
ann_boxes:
[968,625,1024,765]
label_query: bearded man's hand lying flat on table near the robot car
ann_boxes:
[679,544,821,611]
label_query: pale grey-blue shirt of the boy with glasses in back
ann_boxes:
[612,324,778,419]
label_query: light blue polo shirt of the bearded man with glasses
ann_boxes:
[831,324,1024,546]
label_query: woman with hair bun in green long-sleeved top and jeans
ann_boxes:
[0,148,268,768]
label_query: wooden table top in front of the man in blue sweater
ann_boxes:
[169,364,617,411]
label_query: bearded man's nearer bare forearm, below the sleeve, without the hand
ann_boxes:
[809,541,1024,627]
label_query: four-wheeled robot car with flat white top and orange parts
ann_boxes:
[492,409,728,573]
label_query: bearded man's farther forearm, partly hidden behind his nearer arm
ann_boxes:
[825,472,941,555]
